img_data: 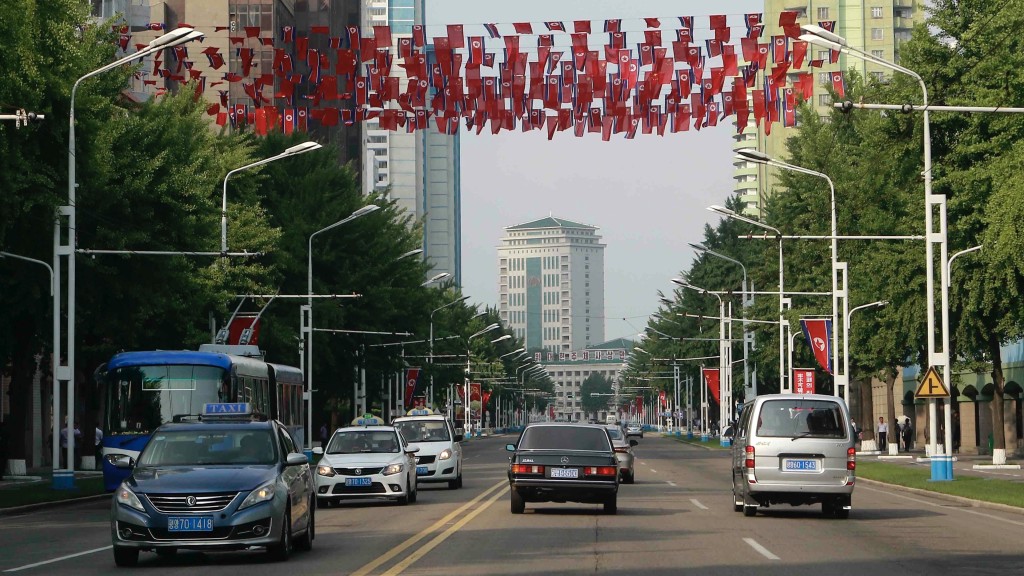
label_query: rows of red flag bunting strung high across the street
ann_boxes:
[125,11,845,140]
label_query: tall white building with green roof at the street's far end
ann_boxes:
[498,216,604,357]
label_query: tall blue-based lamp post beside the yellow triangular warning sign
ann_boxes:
[800,25,953,481]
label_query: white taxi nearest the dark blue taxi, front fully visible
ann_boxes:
[314,425,420,507]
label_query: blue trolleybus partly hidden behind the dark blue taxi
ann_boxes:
[98,344,306,491]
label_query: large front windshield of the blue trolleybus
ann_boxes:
[105,366,231,434]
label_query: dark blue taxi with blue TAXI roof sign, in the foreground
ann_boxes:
[111,404,316,566]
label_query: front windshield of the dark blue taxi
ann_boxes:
[138,428,278,466]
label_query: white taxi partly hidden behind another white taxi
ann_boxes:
[393,410,462,490]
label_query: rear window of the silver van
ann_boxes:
[754,398,849,439]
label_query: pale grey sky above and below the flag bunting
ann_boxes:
[425,0,764,340]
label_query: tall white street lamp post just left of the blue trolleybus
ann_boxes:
[58,27,205,469]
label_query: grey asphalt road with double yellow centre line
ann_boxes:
[0,435,1024,576]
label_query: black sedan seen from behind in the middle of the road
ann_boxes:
[505,422,618,515]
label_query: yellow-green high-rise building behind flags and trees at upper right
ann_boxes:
[733,0,925,215]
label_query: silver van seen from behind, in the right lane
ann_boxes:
[732,394,856,519]
